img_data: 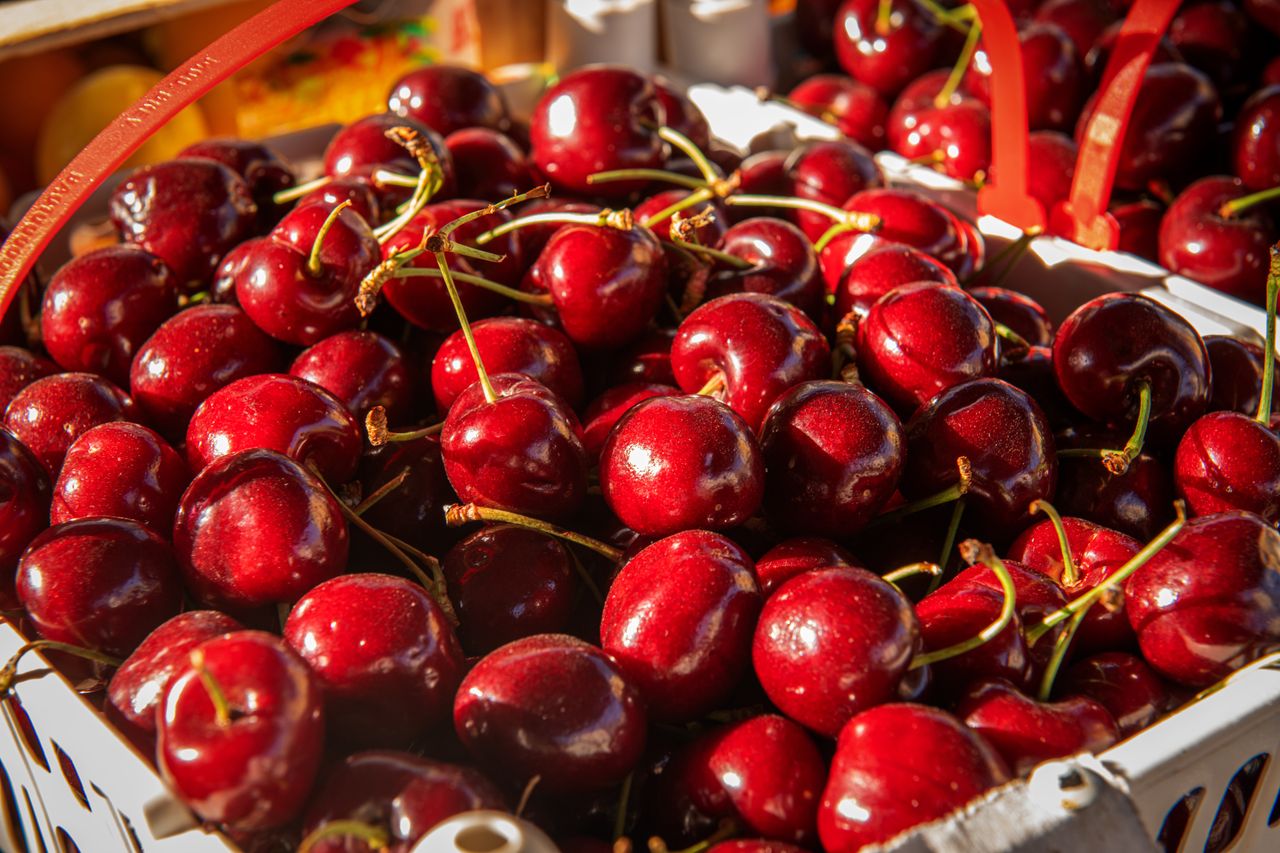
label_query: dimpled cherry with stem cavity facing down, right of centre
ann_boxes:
[671,293,831,429]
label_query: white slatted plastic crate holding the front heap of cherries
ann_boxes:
[0,79,1280,853]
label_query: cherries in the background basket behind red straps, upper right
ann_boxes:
[786,0,1280,305]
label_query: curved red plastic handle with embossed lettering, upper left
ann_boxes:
[0,0,355,316]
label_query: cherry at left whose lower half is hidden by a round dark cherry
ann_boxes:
[187,373,362,485]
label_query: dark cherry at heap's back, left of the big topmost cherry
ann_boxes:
[387,65,507,136]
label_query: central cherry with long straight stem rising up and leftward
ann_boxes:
[440,373,588,519]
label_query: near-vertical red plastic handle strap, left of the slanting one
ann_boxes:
[973,0,1046,231]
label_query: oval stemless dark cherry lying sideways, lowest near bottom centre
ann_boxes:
[453,634,646,793]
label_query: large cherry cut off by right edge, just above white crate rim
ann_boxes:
[1124,512,1280,688]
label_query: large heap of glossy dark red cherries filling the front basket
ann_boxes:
[0,59,1280,853]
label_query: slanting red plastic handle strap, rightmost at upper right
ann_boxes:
[1050,0,1178,251]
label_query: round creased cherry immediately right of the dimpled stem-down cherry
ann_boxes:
[854,282,996,412]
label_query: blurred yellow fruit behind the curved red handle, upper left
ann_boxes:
[36,65,209,183]
